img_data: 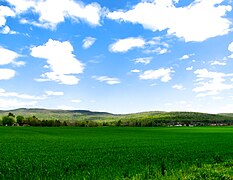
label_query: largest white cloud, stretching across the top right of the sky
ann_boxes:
[107,0,232,42]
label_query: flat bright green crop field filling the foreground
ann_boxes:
[0,127,233,180]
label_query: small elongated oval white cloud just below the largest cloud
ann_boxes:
[109,37,146,53]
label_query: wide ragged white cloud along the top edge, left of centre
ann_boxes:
[7,0,102,29]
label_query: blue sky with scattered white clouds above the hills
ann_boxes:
[0,0,233,113]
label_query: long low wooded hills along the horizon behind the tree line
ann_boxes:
[0,108,233,124]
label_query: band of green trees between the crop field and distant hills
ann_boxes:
[0,112,233,127]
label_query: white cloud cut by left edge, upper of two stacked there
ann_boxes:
[0,46,19,65]
